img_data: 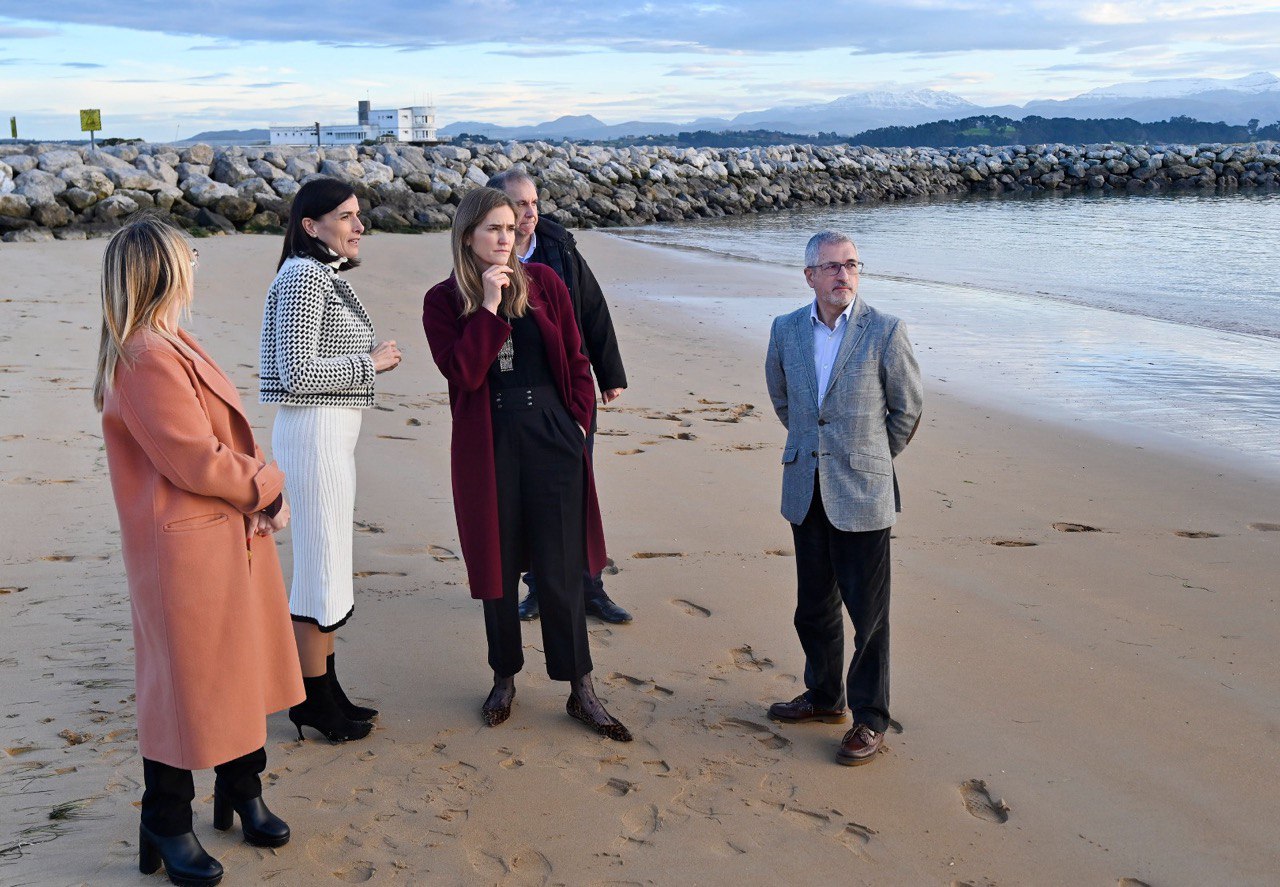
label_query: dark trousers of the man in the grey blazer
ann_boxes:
[791,475,890,732]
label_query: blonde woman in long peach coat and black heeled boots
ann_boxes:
[93,218,303,884]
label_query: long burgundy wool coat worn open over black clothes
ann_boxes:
[422,262,605,600]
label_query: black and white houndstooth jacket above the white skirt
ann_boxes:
[259,256,376,407]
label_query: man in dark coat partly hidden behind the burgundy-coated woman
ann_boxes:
[489,168,631,625]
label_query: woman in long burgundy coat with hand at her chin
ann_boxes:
[422,188,631,742]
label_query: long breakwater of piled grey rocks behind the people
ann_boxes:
[0,142,1280,241]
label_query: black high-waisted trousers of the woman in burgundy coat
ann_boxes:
[484,388,591,681]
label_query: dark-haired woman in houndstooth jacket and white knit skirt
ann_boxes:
[260,178,401,742]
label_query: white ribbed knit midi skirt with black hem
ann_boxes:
[271,406,364,631]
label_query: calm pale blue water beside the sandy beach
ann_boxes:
[620,193,1280,471]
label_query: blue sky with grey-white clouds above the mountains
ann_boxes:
[0,0,1280,141]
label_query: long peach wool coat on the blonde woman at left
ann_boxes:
[102,330,305,769]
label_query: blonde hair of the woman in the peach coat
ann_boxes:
[93,215,196,410]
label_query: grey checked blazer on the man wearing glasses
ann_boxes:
[764,296,924,531]
